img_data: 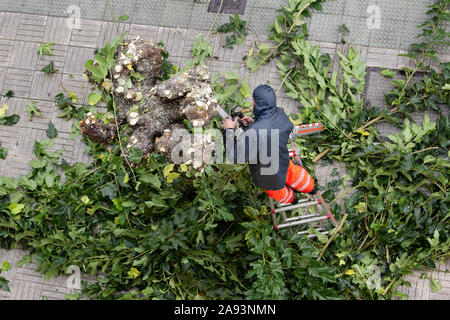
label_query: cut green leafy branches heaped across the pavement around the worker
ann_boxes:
[0,0,450,299]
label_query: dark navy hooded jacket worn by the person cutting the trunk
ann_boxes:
[225,85,294,190]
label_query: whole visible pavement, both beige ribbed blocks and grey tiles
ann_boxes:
[0,0,450,299]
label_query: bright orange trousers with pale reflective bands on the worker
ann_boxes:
[265,160,314,204]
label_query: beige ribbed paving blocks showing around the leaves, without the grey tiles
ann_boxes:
[0,1,450,300]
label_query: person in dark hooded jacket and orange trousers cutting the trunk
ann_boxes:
[222,85,317,204]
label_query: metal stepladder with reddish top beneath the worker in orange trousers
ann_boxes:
[269,123,338,238]
